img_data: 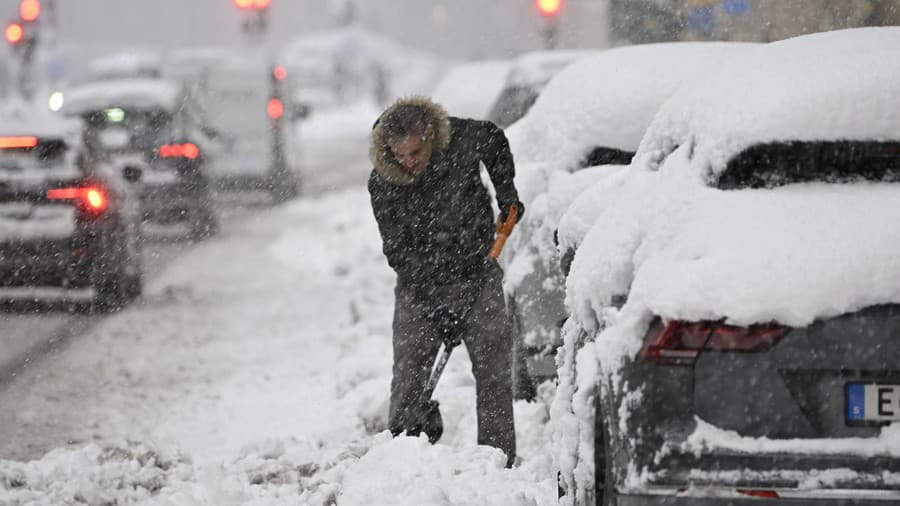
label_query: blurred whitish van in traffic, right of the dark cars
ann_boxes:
[164,48,308,201]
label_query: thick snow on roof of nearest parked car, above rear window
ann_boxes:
[638,27,900,184]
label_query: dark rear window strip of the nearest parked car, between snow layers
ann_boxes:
[715,141,900,190]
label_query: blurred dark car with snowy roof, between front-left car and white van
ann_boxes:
[62,78,218,238]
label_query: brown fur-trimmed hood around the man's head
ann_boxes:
[369,96,450,186]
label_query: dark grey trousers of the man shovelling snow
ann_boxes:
[388,264,516,464]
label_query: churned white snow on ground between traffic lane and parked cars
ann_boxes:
[0,186,556,506]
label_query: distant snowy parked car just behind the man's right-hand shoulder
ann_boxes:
[487,49,598,128]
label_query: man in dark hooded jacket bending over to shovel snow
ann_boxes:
[369,97,524,465]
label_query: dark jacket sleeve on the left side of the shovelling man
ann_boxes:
[369,176,419,280]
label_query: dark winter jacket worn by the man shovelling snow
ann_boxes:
[369,97,518,286]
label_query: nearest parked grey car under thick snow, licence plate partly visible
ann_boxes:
[551,27,900,506]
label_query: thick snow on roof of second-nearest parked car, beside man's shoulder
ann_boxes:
[508,42,758,164]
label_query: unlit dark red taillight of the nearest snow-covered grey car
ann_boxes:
[639,319,790,365]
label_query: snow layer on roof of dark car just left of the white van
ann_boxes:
[63,78,183,115]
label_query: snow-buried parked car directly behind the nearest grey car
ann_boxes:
[504,42,755,394]
